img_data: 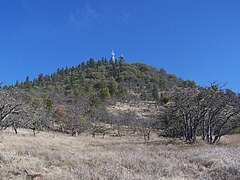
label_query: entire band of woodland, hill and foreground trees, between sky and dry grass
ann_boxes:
[0,57,240,143]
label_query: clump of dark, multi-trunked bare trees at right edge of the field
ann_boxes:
[160,84,240,144]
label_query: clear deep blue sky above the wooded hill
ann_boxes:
[0,0,240,92]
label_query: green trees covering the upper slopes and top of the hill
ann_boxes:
[15,57,188,104]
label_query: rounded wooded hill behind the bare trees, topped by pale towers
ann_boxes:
[0,58,195,134]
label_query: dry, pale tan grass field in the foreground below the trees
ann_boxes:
[0,129,240,180]
